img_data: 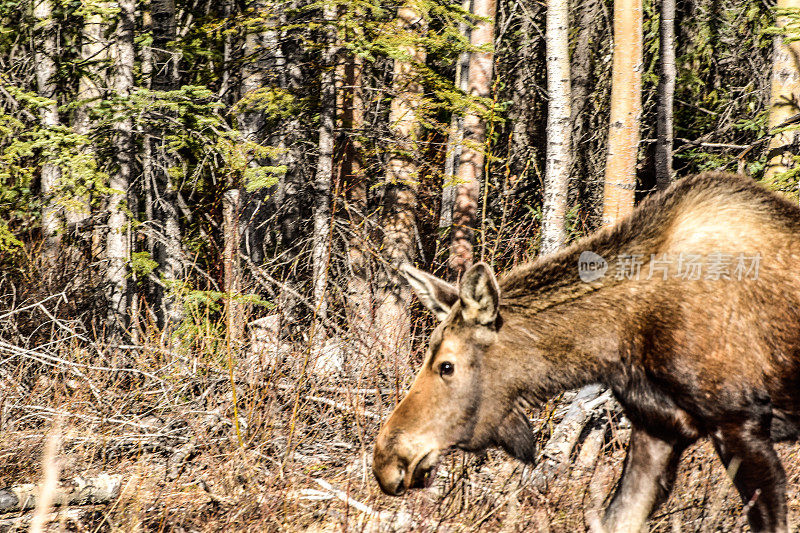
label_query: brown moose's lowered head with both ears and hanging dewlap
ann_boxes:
[373,263,536,496]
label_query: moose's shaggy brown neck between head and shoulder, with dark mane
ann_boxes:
[482,188,681,400]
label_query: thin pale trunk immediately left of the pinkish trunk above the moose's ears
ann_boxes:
[439,0,472,232]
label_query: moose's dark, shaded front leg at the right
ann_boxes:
[712,421,789,533]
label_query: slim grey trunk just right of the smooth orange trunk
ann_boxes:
[656,0,676,190]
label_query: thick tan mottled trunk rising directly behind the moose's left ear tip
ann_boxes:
[375,5,427,356]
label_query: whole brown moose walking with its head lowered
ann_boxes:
[373,173,800,532]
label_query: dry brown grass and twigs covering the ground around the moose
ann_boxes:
[0,326,800,532]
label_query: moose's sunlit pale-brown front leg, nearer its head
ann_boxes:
[603,427,686,533]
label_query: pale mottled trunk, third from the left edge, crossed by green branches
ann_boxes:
[106,0,136,338]
